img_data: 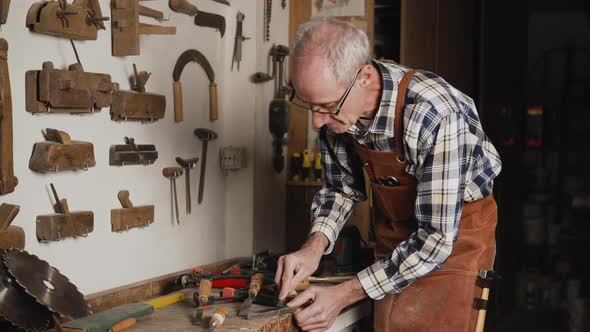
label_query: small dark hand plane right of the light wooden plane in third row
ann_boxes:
[109,137,158,166]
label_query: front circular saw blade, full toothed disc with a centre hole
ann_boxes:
[4,249,90,319]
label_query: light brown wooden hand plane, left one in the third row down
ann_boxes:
[29,128,96,172]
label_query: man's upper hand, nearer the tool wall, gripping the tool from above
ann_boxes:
[275,233,329,300]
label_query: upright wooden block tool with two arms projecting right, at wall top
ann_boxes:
[111,0,176,56]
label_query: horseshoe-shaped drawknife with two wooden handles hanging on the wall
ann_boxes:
[172,49,219,122]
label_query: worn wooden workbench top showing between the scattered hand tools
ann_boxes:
[126,290,371,332]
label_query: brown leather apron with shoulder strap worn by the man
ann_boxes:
[353,71,497,332]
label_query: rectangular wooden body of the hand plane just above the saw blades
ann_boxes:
[36,211,94,242]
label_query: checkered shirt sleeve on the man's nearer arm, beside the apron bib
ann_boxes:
[358,113,469,300]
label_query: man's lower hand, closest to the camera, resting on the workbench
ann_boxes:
[287,278,367,332]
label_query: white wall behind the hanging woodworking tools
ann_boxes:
[0,0,288,294]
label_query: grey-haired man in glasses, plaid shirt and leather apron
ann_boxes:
[275,18,501,331]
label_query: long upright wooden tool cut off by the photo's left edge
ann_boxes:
[0,38,18,195]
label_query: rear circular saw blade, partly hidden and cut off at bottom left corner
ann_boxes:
[0,255,51,332]
